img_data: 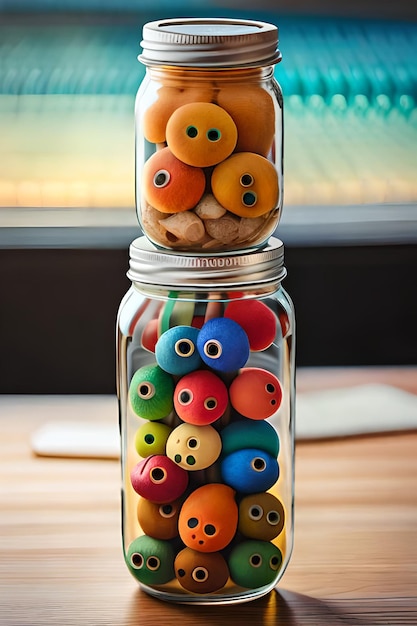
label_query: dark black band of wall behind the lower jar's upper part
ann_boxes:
[0,245,417,394]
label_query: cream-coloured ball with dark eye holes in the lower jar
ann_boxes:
[166,424,222,471]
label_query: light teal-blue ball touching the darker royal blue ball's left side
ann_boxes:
[155,325,202,376]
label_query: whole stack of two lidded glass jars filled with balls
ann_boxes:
[117,19,295,603]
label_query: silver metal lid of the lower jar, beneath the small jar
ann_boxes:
[127,237,287,292]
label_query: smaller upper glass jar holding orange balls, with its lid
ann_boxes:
[135,18,283,254]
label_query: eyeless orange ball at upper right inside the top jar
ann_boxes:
[217,85,275,156]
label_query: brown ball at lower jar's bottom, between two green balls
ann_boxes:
[174,548,229,594]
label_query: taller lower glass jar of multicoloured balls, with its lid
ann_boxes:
[117,237,295,604]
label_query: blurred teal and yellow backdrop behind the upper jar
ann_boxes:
[0,0,417,211]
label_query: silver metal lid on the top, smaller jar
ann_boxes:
[138,18,282,68]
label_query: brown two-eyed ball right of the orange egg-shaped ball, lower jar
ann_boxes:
[238,492,285,541]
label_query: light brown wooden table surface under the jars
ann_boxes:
[0,368,417,626]
